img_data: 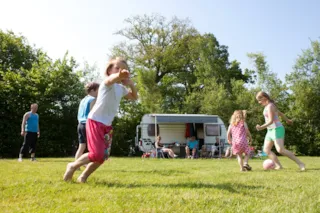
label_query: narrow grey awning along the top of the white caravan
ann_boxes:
[151,115,218,123]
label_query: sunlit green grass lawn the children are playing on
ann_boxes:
[0,157,320,213]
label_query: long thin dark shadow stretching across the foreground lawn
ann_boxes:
[94,180,264,193]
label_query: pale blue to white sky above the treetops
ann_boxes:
[0,0,320,80]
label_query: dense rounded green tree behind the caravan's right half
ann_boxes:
[186,34,252,115]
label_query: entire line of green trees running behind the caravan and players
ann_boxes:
[0,15,320,157]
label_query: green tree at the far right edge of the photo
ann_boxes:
[286,40,320,155]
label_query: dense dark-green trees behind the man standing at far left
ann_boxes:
[0,31,84,157]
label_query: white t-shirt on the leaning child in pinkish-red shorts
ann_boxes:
[88,81,129,126]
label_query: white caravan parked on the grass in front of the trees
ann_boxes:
[135,114,227,157]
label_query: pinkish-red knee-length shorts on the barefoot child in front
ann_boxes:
[86,119,112,164]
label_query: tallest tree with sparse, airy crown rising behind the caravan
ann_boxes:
[113,15,198,112]
